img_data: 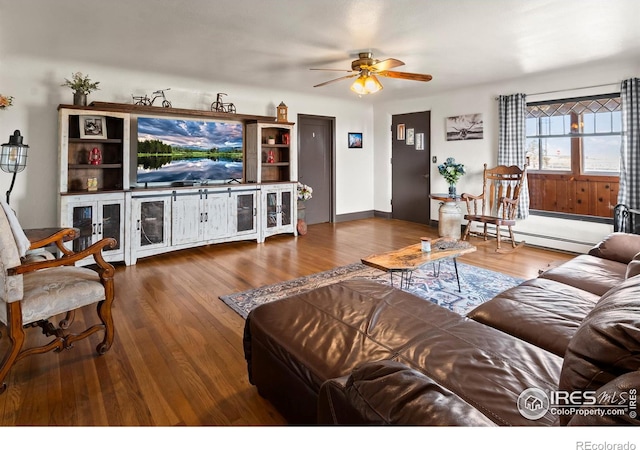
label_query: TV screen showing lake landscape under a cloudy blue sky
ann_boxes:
[136,117,243,183]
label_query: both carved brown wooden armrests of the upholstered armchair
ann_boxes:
[7,239,116,279]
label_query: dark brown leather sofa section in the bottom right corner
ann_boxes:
[567,371,640,426]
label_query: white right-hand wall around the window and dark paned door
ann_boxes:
[373,61,640,252]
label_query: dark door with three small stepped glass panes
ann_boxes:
[391,111,431,225]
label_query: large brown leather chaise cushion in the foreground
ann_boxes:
[245,280,562,425]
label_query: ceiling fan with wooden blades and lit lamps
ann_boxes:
[310,52,432,95]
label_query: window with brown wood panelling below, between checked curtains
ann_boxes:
[526,94,622,220]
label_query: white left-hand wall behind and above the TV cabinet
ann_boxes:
[0,57,374,228]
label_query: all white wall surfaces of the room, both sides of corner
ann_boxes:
[0,52,640,251]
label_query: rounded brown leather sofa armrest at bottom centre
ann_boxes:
[318,360,495,426]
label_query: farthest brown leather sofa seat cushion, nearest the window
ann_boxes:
[539,255,633,296]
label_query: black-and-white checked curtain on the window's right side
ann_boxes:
[618,78,640,227]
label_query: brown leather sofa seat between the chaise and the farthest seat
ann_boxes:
[467,278,600,356]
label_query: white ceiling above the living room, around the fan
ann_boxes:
[0,0,640,100]
